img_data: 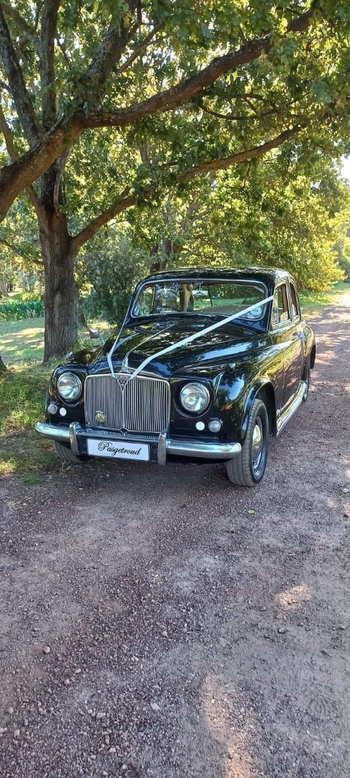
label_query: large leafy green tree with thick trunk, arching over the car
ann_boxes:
[0,0,350,360]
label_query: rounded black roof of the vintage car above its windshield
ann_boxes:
[143,267,291,288]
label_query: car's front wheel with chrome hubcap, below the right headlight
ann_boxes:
[226,399,269,486]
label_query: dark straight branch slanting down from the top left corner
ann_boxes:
[0,3,41,146]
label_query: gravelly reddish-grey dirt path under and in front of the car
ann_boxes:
[0,295,350,778]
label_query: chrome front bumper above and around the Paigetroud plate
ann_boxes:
[35,421,241,465]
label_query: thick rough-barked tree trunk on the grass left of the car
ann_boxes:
[40,208,78,362]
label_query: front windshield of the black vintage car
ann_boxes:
[132,281,266,321]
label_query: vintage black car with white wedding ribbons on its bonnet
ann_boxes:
[36,268,316,486]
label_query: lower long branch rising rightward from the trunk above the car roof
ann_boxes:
[71,125,304,256]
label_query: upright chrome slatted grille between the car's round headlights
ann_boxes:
[85,373,170,433]
